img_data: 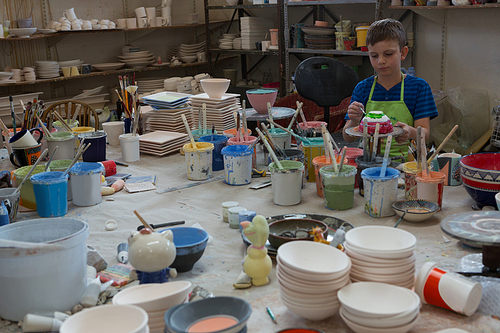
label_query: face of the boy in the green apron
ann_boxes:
[368,40,408,77]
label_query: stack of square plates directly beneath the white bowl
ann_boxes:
[189,93,241,133]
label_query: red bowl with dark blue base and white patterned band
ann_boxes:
[460,153,500,208]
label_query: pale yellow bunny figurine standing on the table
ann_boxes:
[241,215,273,286]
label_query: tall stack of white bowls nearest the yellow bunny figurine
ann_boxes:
[276,241,351,320]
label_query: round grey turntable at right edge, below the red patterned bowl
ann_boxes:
[441,211,500,272]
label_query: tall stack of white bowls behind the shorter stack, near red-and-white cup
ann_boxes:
[344,226,417,289]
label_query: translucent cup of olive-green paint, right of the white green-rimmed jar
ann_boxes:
[319,164,357,210]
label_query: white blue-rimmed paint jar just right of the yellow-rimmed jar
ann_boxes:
[222,145,254,185]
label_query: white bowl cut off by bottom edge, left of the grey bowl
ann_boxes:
[59,305,148,333]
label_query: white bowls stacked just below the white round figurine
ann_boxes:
[113,281,192,333]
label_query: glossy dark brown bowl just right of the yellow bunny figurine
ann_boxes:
[269,219,328,248]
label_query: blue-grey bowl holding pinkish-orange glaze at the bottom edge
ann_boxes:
[165,296,252,333]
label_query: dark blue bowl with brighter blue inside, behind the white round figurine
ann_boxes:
[160,227,208,272]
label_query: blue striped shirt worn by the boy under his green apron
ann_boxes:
[345,75,438,120]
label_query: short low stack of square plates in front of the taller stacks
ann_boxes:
[139,131,189,156]
